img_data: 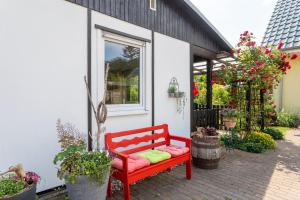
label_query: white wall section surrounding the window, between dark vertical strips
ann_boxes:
[92,12,152,148]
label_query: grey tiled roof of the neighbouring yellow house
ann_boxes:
[262,0,300,49]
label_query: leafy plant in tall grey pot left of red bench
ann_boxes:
[53,120,111,200]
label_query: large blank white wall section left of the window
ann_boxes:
[0,0,87,190]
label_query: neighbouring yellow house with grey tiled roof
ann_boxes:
[262,0,300,115]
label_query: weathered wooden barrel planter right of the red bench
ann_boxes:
[192,136,221,169]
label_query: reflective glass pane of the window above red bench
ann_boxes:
[105,41,140,104]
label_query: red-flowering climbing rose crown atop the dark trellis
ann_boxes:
[220,31,297,96]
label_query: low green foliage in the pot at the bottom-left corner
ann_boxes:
[0,178,26,199]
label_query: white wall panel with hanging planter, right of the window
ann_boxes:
[154,33,190,141]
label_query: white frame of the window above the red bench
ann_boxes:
[101,31,146,116]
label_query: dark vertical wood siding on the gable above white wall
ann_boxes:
[68,0,229,52]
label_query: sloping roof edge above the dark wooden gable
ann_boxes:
[184,0,233,49]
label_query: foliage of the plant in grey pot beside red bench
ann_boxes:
[53,120,111,185]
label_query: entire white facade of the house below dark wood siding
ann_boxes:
[0,0,190,191]
